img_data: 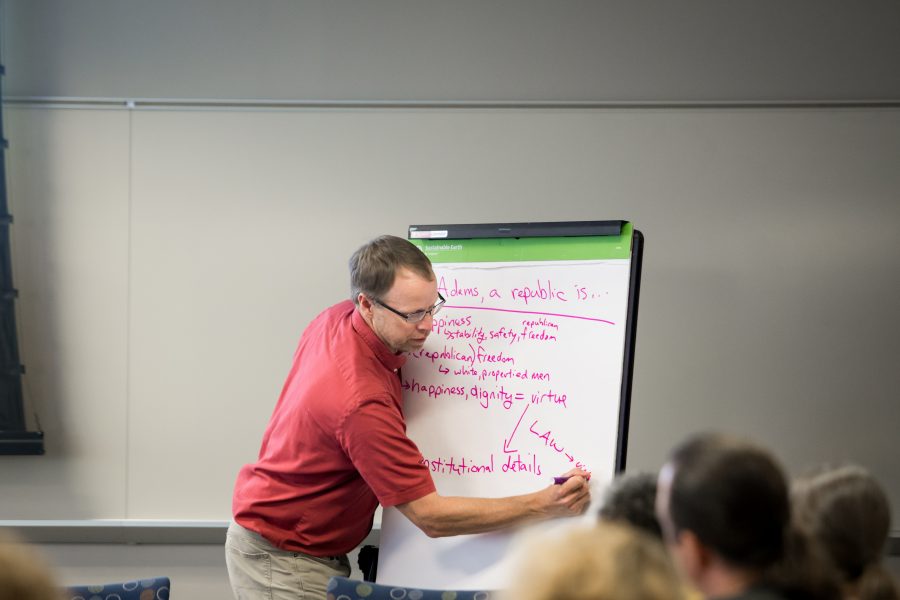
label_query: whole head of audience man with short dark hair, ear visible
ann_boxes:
[656,434,790,594]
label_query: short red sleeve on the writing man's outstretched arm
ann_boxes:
[338,399,435,506]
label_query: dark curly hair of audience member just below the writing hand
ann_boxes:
[598,473,662,540]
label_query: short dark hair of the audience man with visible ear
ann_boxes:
[669,434,790,569]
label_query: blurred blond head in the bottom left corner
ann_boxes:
[0,534,62,600]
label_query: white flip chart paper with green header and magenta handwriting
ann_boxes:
[378,226,632,589]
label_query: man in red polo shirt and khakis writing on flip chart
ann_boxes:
[226,236,590,600]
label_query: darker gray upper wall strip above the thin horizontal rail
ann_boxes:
[3,0,900,101]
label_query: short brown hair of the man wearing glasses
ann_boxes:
[350,235,434,302]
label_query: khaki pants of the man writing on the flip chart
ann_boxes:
[225,522,350,600]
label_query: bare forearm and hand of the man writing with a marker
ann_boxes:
[397,469,590,537]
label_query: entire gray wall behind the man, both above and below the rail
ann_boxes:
[0,0,900,597]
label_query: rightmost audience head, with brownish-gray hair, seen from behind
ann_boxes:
[792,465,900,600]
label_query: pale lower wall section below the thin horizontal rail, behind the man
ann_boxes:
[2,106,900,519]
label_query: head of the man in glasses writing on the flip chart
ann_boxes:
[350,235,443,352]
